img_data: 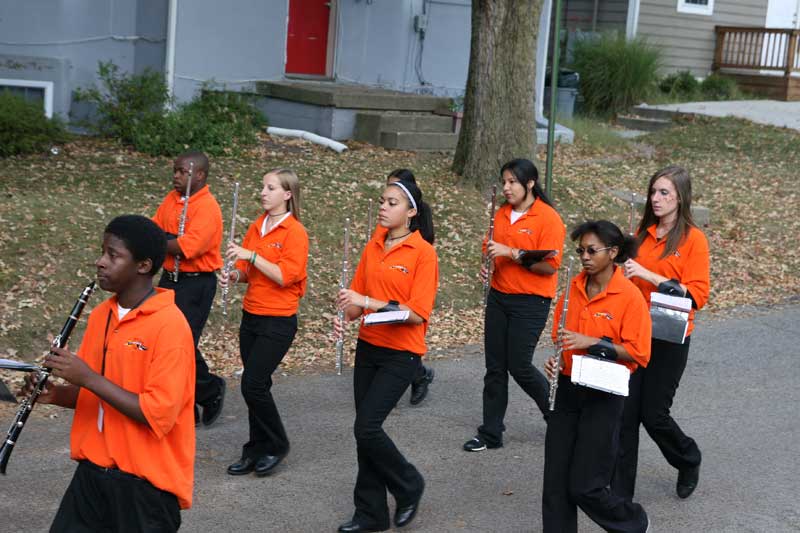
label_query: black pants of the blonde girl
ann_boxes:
[239,311,297,458]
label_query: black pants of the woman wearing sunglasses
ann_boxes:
[542,374,647,533]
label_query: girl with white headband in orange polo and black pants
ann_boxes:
[334,180,439,533]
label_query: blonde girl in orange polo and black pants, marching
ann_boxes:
[220,169,308,476]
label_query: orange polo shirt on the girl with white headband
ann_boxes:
[350,231,439,356]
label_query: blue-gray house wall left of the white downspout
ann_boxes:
[0,0,167,116]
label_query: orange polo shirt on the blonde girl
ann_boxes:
[236,213,308,316]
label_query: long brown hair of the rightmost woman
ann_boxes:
[637,165,696,259]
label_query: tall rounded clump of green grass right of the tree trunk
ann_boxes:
[572,33,661,116]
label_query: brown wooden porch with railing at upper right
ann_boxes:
[712,26,800,101]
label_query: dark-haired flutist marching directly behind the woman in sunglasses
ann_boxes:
[464,159,566,452]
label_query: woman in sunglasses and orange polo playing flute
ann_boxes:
[542,220,650,533]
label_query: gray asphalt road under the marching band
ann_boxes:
[0,301,800,533]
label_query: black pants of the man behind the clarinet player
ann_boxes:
[158,272,225,406]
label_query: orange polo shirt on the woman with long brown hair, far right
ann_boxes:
[631,224,711,336]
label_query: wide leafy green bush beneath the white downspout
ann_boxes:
[77,63,266,156]
